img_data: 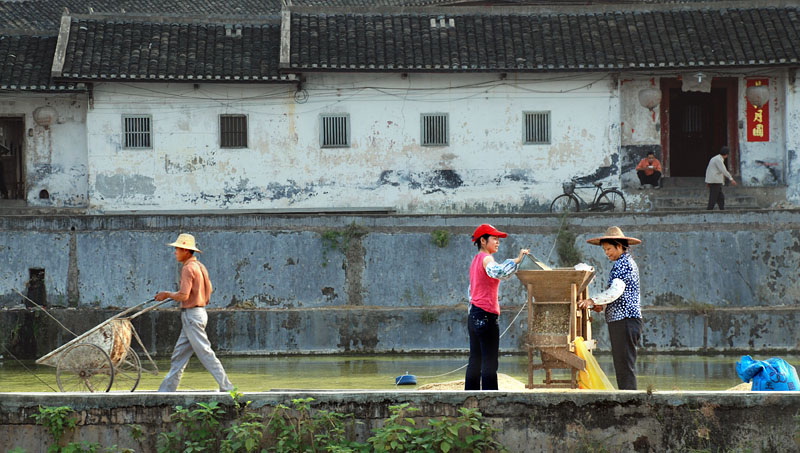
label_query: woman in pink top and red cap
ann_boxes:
[464,223,528,390]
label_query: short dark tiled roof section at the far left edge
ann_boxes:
[0,34,79,91]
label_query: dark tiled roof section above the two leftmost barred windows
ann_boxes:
[61,18,288,81]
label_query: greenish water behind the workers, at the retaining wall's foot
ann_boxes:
[0,354,800,392]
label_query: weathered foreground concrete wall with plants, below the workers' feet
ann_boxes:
[0,391,800,453]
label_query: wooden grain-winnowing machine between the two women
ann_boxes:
[517,268,595,388]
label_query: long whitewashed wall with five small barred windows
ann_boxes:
[87,74,620,213]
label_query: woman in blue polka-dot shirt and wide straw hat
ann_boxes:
[578,227,642,390]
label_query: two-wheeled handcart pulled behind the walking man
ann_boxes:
[36,299,172,392]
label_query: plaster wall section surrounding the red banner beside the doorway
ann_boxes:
[737,70,797,187]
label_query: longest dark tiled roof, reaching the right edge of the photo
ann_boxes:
[288,5,800,72]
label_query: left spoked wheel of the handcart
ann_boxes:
[56,343,114,392]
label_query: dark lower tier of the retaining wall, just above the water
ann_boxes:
[0,307,800,359]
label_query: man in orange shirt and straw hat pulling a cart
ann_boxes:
[155,233,233,392]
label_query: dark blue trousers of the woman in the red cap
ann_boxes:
[464,305,500,390]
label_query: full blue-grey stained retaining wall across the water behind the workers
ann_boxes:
[0,211,800,356]
